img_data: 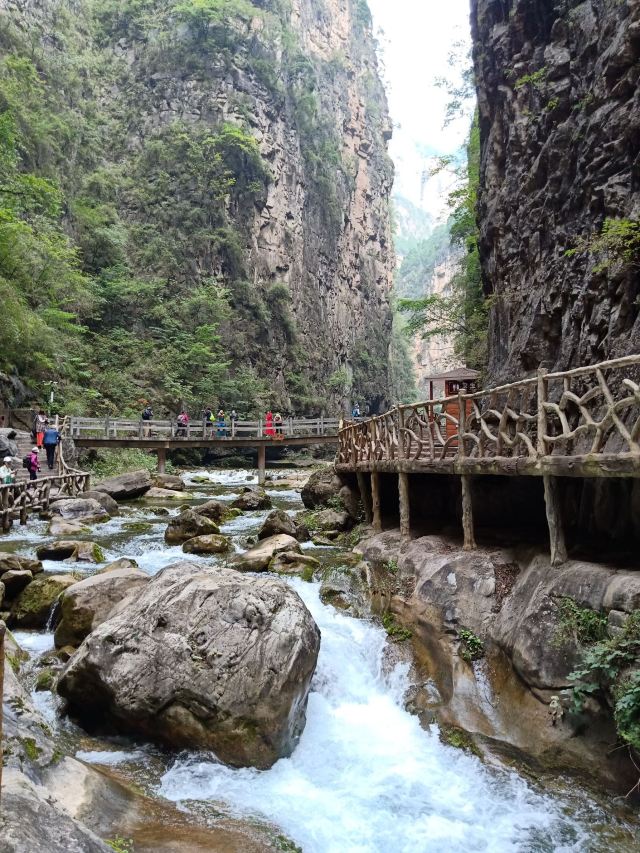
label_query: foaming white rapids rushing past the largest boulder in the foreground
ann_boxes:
[160,580,589,853]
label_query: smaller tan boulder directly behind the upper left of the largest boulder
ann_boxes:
[54,569,149,648]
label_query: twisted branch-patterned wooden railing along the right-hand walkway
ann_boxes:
[338,355,640,466]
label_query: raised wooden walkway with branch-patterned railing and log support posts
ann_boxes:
[336,355,640,563]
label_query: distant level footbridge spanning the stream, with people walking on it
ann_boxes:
[65,417,339,484]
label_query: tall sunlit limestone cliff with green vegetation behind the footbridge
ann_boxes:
[0,0,394,412]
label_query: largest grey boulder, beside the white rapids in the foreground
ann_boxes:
[58,563,320,769]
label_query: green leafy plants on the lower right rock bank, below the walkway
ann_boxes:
[569,610,640,752]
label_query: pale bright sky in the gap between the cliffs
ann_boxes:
[369,0,470,217]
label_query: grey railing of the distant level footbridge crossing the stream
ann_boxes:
[66,416,339,440]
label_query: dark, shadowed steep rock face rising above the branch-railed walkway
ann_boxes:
[471,0,640,380]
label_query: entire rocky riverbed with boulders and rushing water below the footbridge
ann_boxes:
[0,471,637,853]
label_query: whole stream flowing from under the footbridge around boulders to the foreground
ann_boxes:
[5,471,638,853]
